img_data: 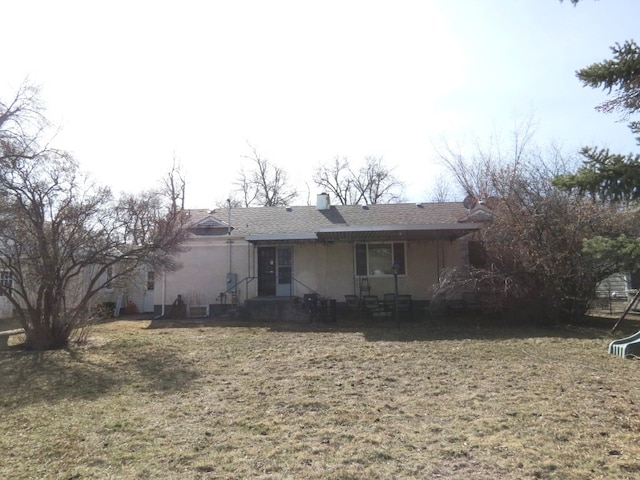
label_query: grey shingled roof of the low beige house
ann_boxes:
[185,202,491,242]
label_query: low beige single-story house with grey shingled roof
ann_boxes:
[154,194,491,316]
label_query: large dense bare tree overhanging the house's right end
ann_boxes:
[436,125,624,323]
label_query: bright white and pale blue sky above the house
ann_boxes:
[0,0,640,208]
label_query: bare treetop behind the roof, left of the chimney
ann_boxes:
[235,147,298,207]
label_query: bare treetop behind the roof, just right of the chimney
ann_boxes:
[313,156,404,205]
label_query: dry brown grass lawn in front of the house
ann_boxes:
[0,320,640,479]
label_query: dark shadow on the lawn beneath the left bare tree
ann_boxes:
[0,345,199,407]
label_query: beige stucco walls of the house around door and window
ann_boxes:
[155,237,466,305]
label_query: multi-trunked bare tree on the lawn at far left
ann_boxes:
[0,84,186,350]
